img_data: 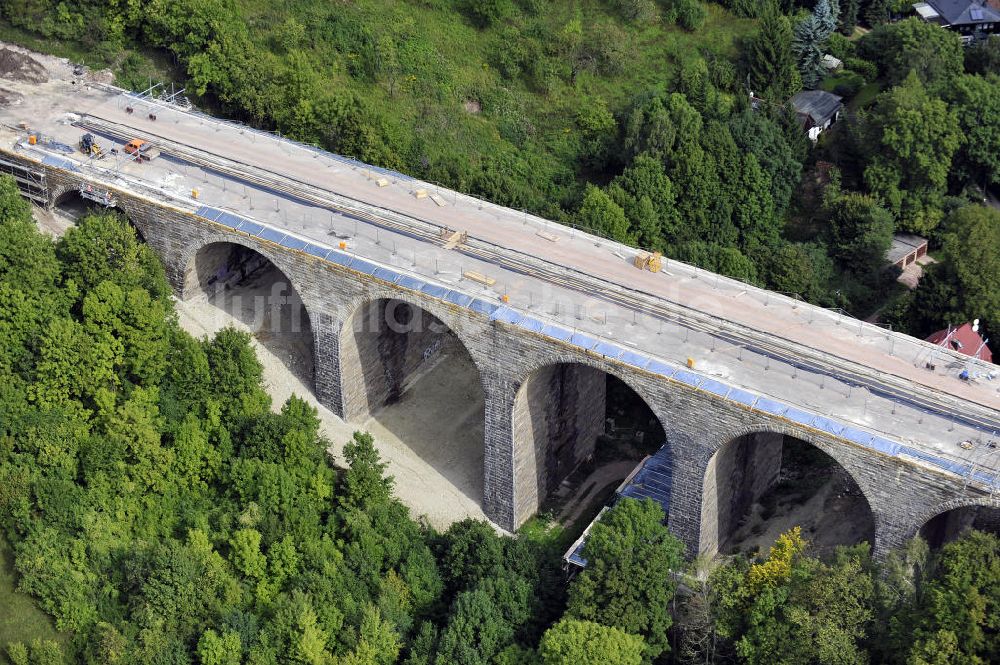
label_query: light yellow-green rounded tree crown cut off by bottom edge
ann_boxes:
[538,619,645,665]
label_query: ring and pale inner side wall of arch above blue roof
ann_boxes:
[510,354,671,524]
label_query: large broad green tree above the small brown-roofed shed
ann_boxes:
[864,73,962,233]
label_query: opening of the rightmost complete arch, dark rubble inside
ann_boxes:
[699,432,875,555]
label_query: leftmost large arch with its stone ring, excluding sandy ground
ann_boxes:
[182,234,321,391]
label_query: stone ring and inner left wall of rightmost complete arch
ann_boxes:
[698,422,881,555]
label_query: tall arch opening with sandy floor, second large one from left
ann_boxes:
[340,298,486,526]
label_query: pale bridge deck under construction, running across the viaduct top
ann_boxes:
[0,61,1000,488]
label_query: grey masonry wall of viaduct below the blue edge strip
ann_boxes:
[5,153,998,555]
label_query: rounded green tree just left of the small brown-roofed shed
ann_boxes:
[827,192,894,274]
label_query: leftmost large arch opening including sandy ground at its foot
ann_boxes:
[179,242,314,390]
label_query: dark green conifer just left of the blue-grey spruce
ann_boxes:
[743,0,802,104]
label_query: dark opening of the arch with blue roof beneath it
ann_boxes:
[512,363,667,523]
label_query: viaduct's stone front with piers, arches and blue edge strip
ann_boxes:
[0,123,1000,555]
